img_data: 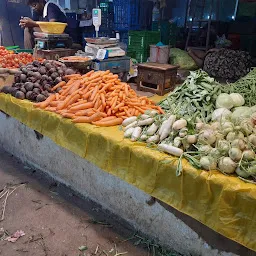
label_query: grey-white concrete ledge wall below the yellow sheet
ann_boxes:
[0,113,252,256]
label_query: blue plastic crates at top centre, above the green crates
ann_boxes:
[113,0,141,31]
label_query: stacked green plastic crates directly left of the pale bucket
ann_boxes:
[127,31,161,63]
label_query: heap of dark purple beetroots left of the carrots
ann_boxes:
[2,60,75,102]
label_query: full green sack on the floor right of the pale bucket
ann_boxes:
[170,48,198,70]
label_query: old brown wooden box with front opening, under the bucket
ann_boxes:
[137,63,178,96]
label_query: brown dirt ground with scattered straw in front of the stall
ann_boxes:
[0,150,149,256]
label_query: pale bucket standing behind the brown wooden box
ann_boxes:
[150,45,170,64]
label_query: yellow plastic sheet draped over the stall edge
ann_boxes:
[0,94,256,251]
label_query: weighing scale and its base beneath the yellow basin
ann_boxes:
[34,32,76,60]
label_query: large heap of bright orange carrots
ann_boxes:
[34,71,163,126]
